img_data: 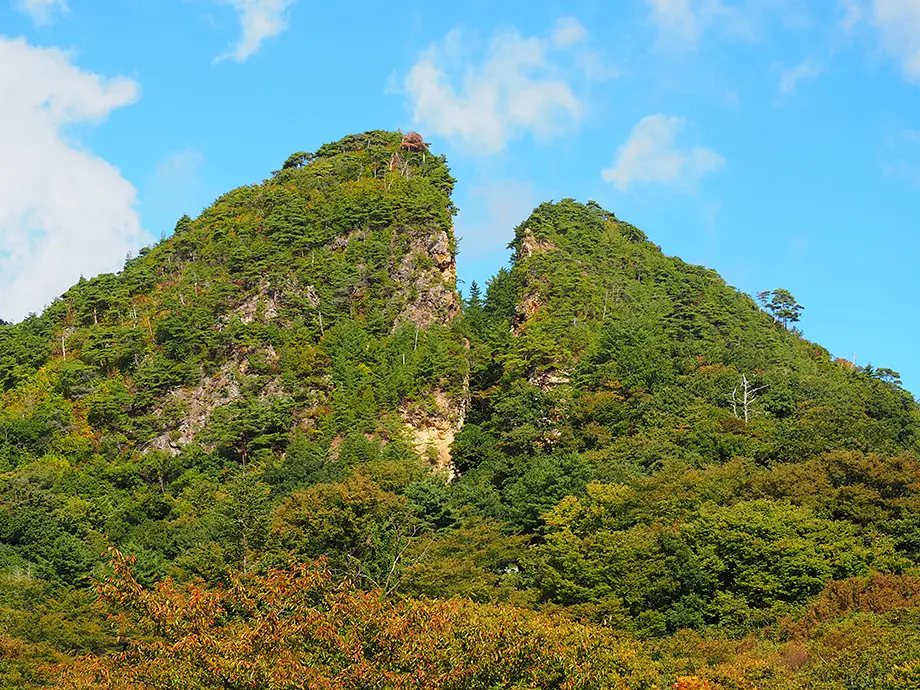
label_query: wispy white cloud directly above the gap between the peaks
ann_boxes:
[401,24,582,155]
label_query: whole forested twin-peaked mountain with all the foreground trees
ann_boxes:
[0,131,920,690]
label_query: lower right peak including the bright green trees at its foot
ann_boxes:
[455,200,920,636]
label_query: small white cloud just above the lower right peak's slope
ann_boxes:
[601,114,725,191]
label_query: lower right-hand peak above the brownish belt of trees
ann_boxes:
[464,196,920,471]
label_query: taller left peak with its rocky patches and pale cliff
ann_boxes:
[0,132,467,668]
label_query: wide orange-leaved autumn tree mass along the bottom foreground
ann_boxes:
[59,551,654,690]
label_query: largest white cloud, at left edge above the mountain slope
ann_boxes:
[0,37,148,320]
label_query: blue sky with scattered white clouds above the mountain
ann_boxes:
[0,0,920,392]
